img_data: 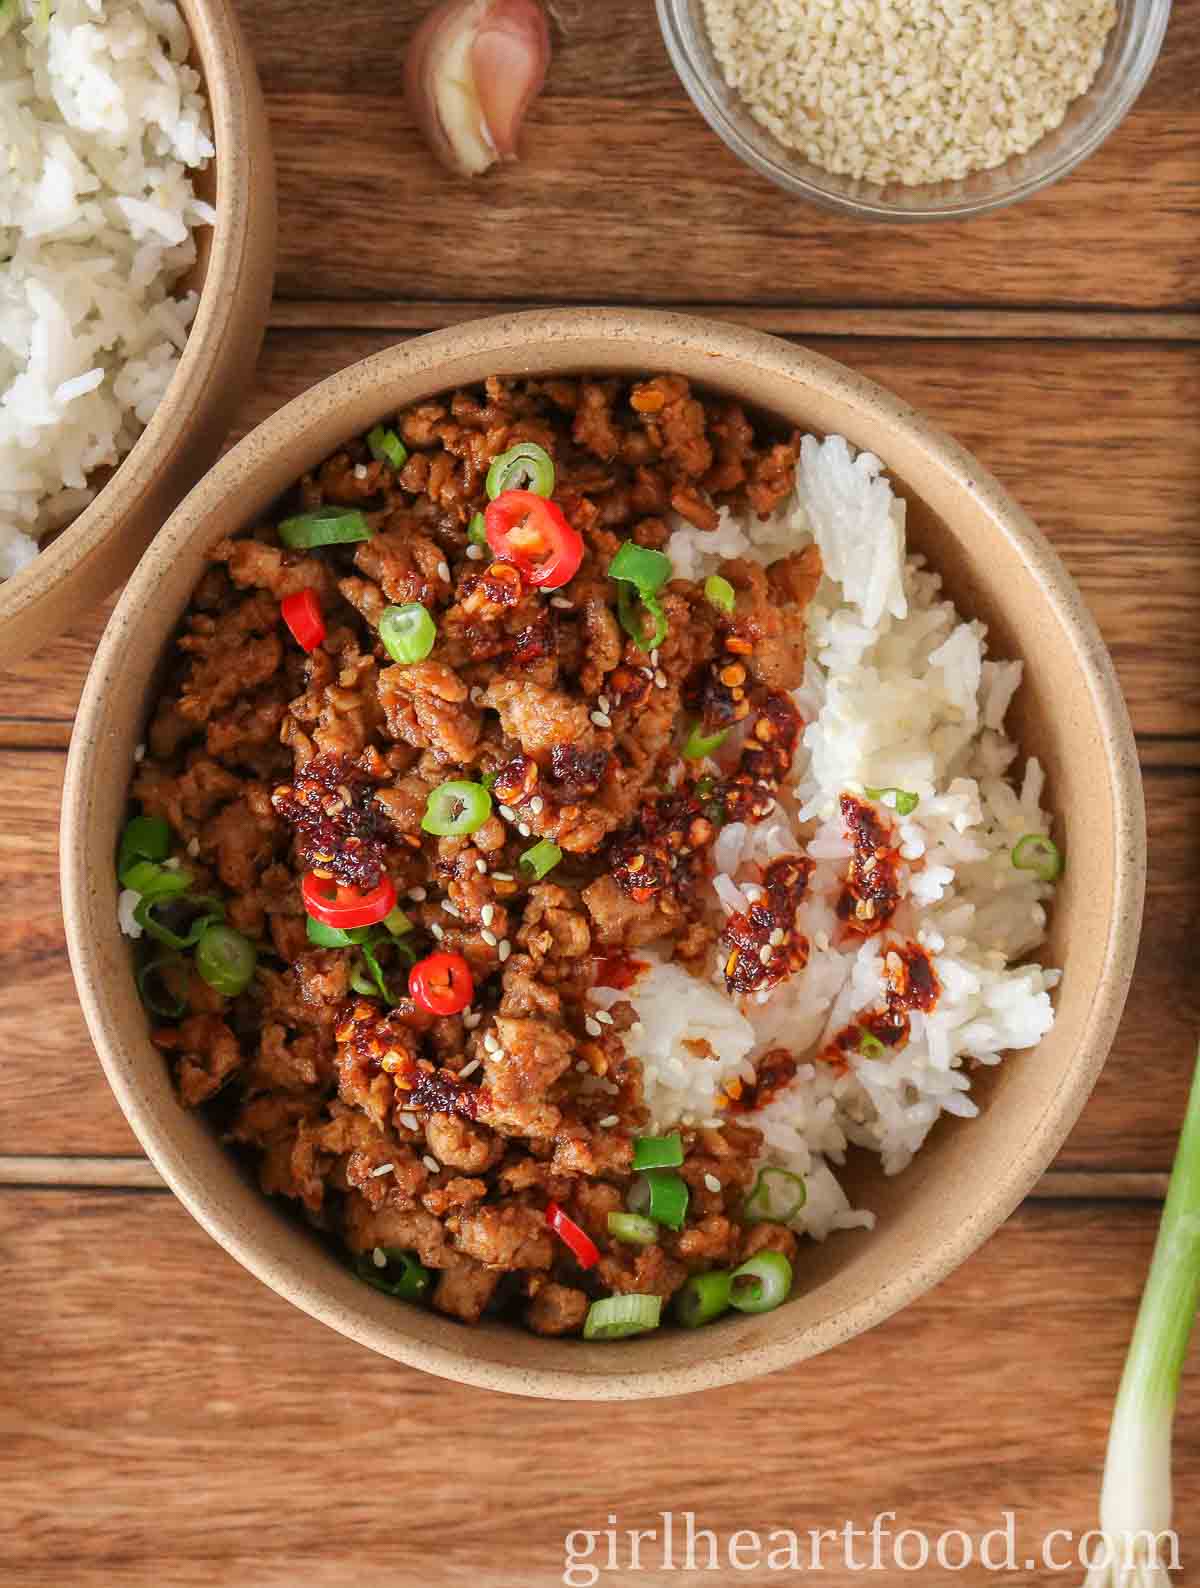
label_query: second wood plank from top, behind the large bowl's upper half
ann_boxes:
[0,330,1200,743]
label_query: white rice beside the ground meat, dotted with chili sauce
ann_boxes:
[619,437,1059,1239]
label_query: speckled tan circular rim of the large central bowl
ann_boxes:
[60,308,1146,1401]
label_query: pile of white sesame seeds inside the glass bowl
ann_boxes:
[703,0,1116,186]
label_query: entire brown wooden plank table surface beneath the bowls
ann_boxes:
[0,0,1200,1588]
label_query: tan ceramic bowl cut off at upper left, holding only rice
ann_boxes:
[0,0,275,667]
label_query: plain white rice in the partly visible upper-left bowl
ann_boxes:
[0,0,216,578]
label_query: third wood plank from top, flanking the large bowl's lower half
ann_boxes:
[0,751,1200,1174]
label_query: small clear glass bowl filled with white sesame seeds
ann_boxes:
[657,0,1171,221]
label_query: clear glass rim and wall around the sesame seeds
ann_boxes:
[656,0,1171,222]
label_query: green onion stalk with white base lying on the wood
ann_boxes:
[1086,1054,1200,1588]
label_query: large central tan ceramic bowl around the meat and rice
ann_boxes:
[62,310,1144,1399]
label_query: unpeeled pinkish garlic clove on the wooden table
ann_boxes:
[405,0,549,176]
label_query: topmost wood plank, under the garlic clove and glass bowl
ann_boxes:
[231,0,1200,308]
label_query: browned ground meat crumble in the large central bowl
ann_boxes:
[133,375,825,1334]
